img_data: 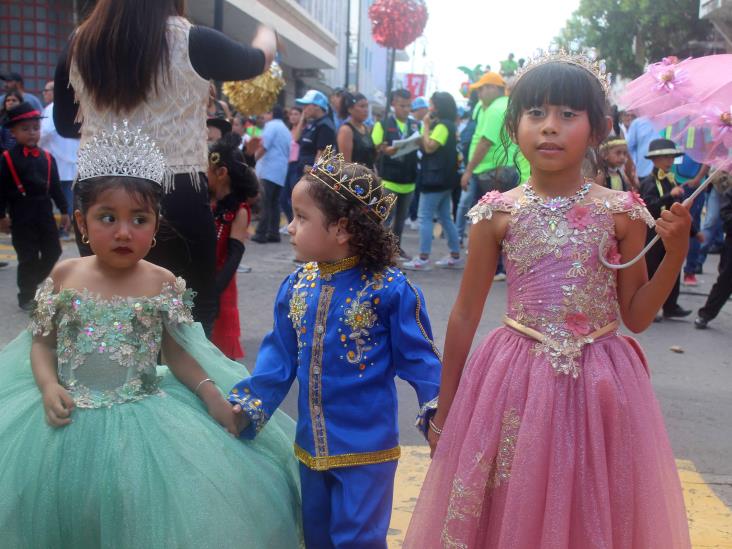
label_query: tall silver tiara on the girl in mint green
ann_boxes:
[77,120,165,185]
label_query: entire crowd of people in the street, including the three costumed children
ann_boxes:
[0,0,732,548]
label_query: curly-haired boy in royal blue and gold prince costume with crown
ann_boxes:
[229,150,441,549]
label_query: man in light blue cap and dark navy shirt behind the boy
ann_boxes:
[293,90,338,180]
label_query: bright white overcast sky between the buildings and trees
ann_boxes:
[397,0,579,93]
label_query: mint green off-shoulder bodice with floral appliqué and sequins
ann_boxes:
[30,278,193,408]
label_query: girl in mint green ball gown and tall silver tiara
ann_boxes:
[0,126,302,549]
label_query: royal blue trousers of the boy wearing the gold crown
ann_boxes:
[300,461,397,549]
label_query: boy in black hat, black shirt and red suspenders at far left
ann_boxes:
[0,102,69,310]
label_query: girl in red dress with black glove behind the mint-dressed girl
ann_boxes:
[208,133,259,360]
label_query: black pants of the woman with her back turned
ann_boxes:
[76,173,218,335]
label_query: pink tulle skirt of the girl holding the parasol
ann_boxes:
[404,327,690,549]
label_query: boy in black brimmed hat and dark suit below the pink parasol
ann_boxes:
[640,139,698,320]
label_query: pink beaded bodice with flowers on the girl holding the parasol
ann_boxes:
[468,187,654,377]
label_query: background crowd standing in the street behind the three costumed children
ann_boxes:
[0,65,729,330]
